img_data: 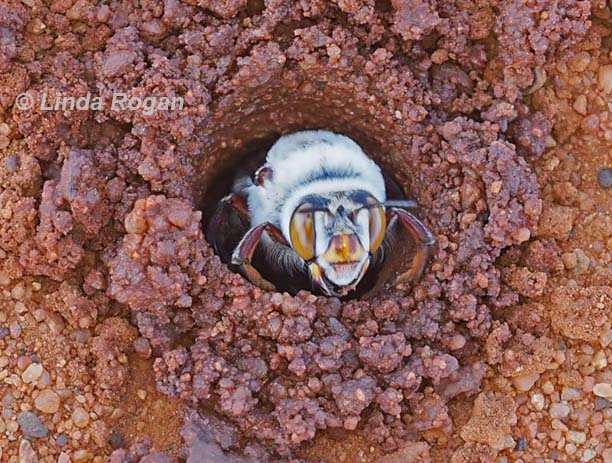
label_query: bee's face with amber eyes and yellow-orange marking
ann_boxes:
[289,191,386,295]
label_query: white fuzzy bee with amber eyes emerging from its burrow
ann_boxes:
[207,130,435,297]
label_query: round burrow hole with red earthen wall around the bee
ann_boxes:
[194,77,418,299]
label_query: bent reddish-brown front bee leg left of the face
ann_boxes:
[232,222,289,291]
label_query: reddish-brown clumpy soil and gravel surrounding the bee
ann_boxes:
[0,0,612,463]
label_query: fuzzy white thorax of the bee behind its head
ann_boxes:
[246,130,386,239]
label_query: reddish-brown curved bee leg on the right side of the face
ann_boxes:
[391,208,436,284]
